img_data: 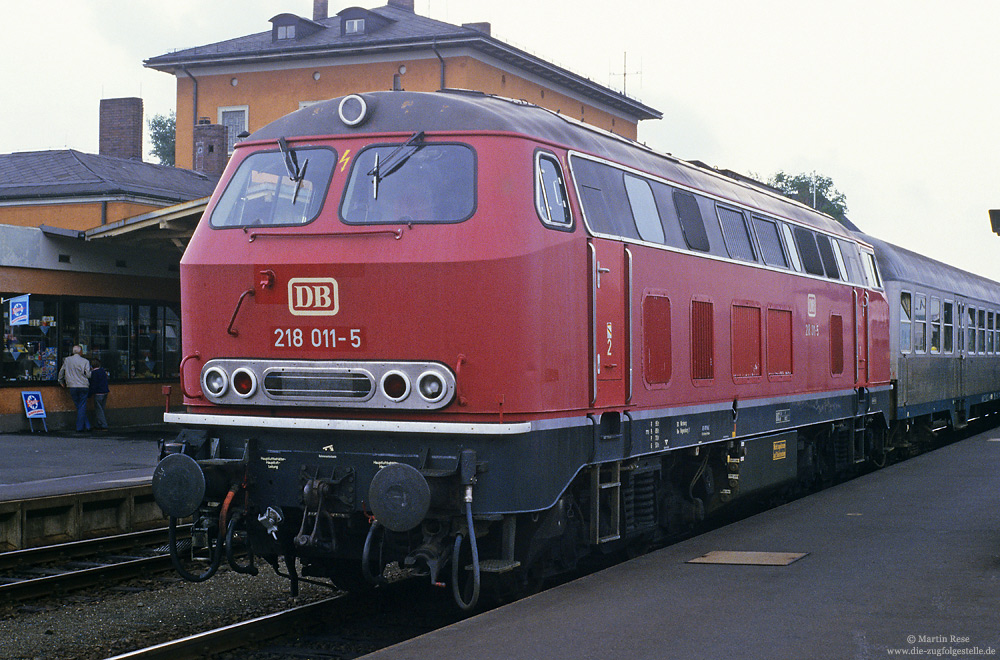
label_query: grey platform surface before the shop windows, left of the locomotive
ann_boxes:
[0,425,170,501]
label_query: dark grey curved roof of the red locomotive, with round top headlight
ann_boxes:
[248,90,852,237]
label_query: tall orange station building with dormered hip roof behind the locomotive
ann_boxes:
[145,0,661,167]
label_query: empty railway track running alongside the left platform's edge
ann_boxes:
[0,529,187,602]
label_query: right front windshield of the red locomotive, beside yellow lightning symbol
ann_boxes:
[340,143,476,224]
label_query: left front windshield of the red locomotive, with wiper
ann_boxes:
[210,146,337,227]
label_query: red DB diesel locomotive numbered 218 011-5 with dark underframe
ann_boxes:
[154,87,895,608]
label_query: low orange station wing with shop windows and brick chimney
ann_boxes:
[0,98,217,431]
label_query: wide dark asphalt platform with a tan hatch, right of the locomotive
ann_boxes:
[365,430,1000,660]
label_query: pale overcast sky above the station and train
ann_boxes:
[0,0,1000,280]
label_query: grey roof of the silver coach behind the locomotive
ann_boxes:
[861,234,1000,302]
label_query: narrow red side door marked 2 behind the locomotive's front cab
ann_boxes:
[589,238,632,407]
